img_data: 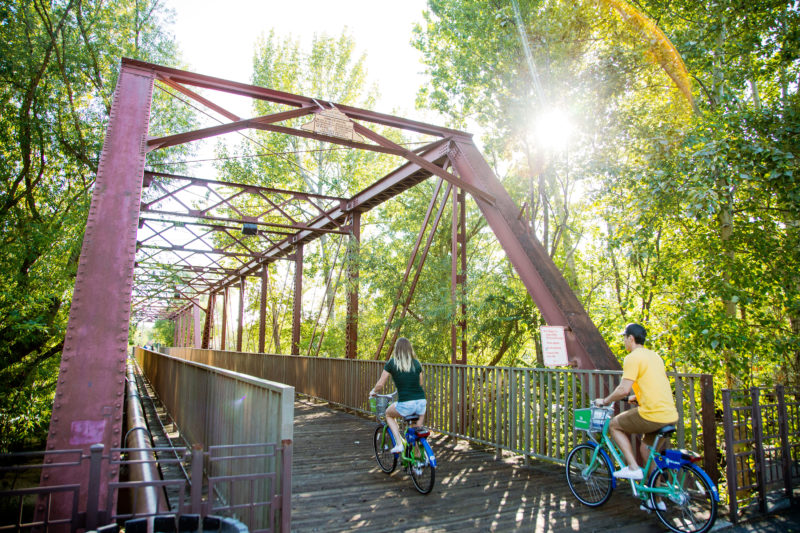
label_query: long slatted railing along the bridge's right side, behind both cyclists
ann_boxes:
[168,348,719,481]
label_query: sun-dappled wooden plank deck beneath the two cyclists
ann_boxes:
[292,400,666,533]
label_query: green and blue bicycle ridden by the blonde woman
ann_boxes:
[370,388,436,494]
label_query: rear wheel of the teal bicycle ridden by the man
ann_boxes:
[647,464,717,533]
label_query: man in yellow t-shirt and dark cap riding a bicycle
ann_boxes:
[594,324,678,480]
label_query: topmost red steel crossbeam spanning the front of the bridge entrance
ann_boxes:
[122,58,472,139]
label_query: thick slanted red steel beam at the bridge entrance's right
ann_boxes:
[450,140,621,370]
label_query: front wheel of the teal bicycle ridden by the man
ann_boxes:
[566,444,614,507]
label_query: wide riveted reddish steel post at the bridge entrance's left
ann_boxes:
[41,60,154,520]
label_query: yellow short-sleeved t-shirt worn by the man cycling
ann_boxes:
[622,348,678,424]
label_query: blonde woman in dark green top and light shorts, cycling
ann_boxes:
[369,337,427,453]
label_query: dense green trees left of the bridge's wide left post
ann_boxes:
[0,0,186,451]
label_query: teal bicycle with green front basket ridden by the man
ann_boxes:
[566,407,719,533]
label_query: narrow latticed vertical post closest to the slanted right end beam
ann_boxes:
[450,189,467,365]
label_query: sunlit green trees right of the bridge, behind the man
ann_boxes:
[415,0,800,384]
